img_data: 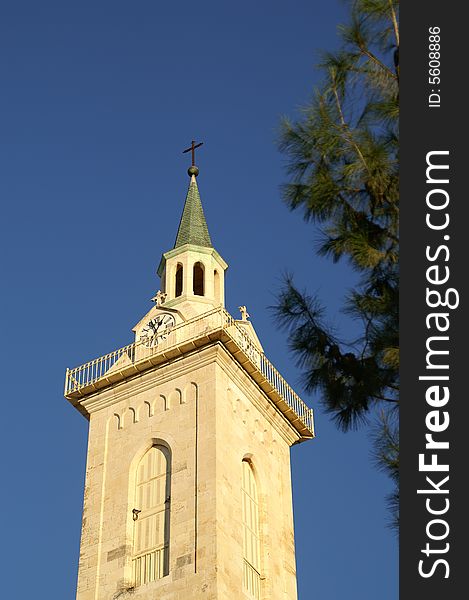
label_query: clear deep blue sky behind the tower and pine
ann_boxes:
[0,0,398,600]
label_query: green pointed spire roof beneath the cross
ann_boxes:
[174,169,213,248]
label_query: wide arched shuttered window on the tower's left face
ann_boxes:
[132,445,171,586]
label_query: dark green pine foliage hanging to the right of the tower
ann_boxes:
[276,0,400,518]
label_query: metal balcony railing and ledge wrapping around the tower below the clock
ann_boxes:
[65,307,314,437]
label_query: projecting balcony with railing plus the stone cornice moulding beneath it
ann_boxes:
[65,307,314,439]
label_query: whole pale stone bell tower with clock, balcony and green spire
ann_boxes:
[65,162,314,600]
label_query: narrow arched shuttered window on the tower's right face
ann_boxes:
[242,460,261,600]
